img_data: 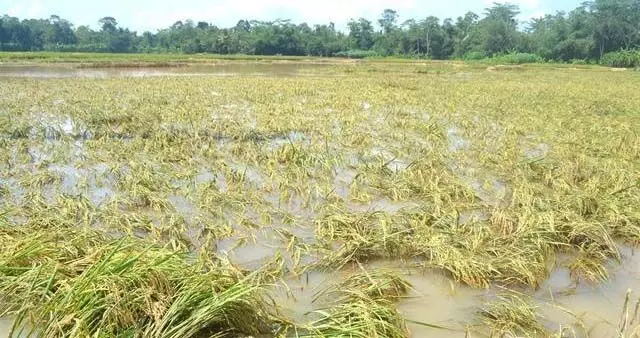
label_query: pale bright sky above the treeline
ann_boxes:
[0,0,582,31]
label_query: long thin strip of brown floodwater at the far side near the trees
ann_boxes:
[0,62,330,79]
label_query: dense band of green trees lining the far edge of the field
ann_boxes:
[0,0,640,61]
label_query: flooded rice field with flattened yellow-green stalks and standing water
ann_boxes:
[0,61,640,338]
